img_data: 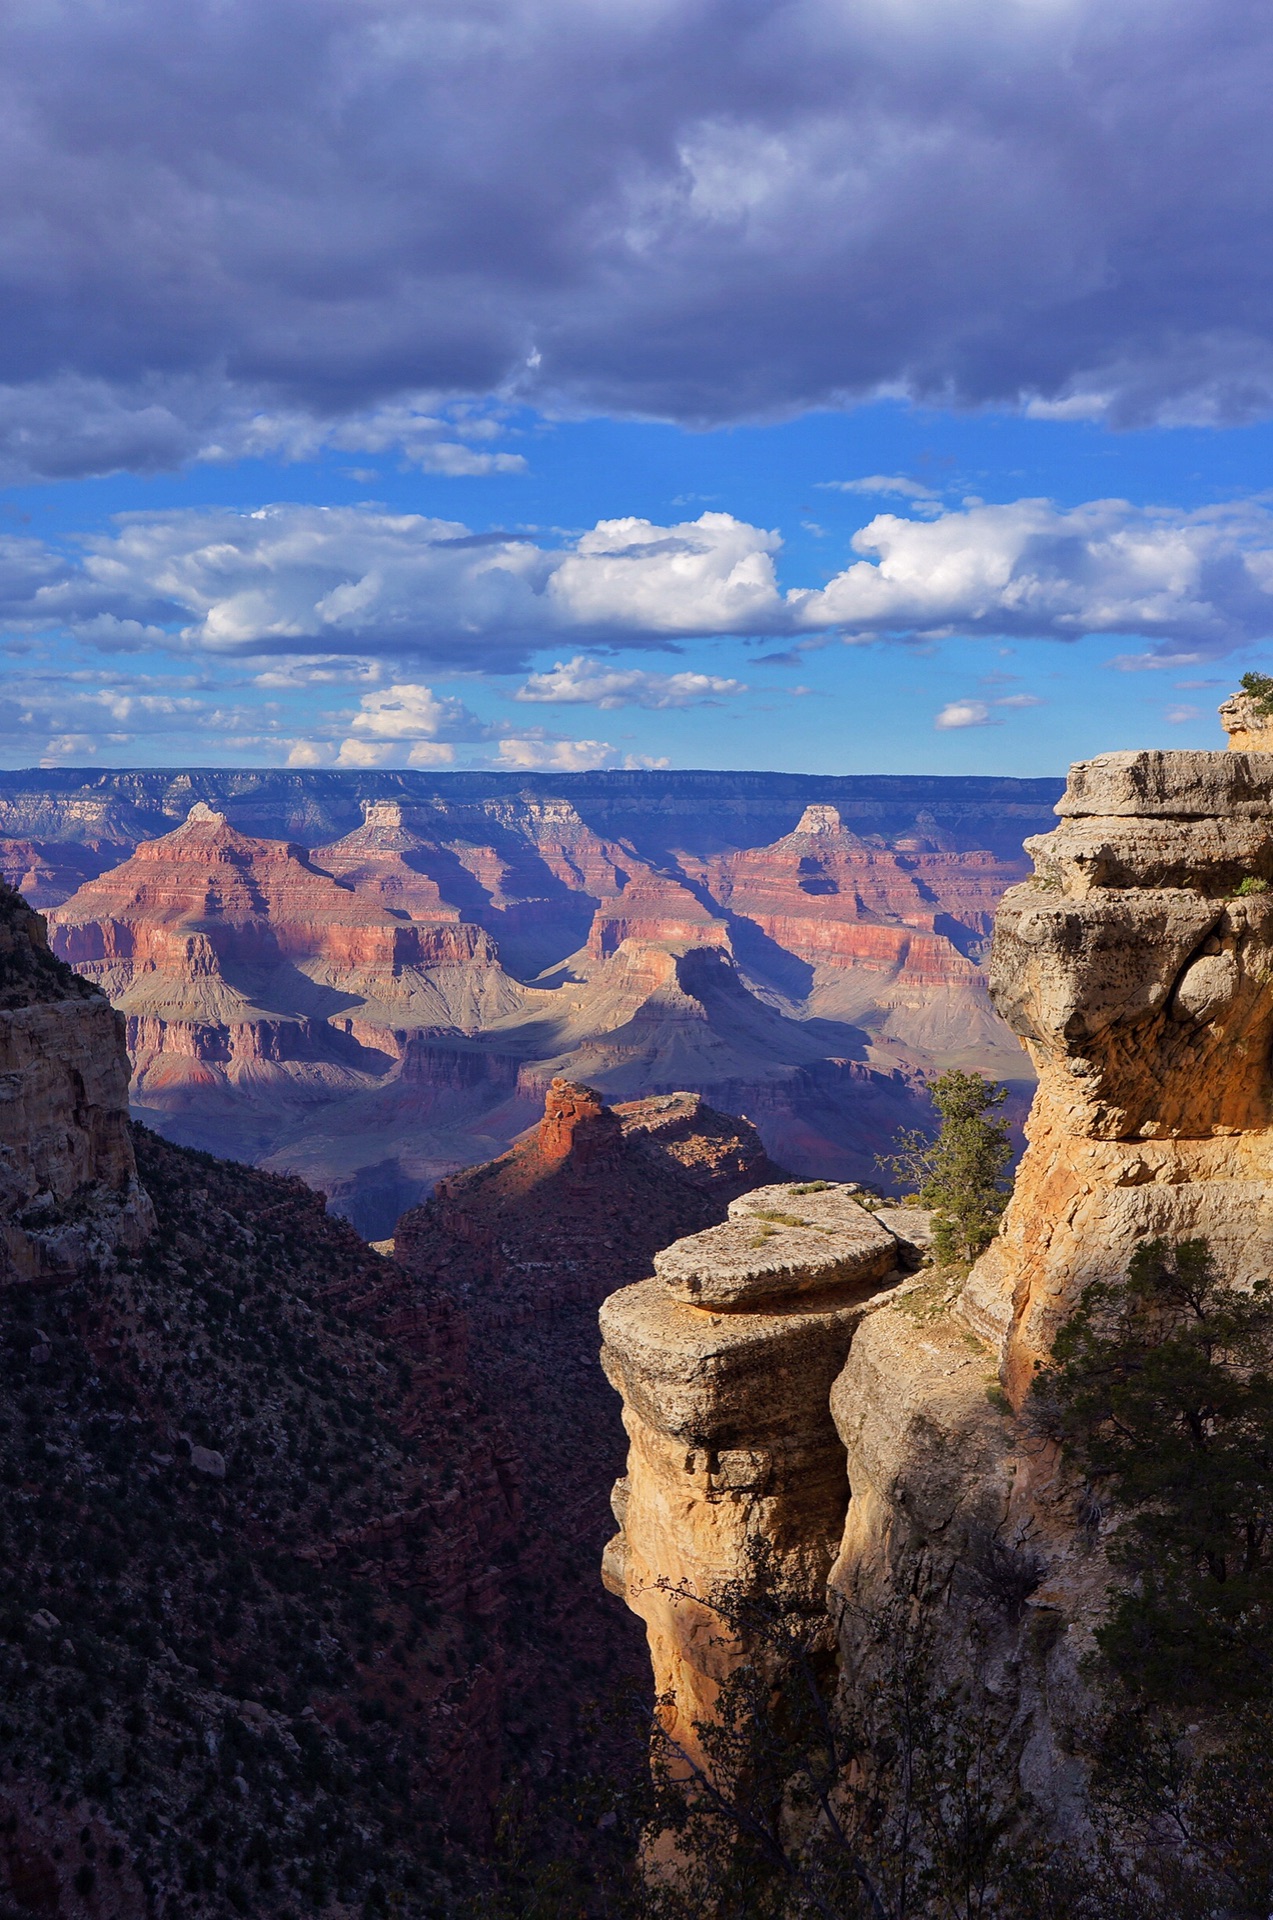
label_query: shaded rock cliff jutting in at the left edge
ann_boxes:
[0,885,152,1286]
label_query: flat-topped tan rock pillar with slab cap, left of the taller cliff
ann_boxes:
[601,1183,914,1757]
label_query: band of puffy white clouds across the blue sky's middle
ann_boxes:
[12,499,1273,668]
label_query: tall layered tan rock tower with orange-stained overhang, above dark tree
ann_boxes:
[964,753,1273,1404]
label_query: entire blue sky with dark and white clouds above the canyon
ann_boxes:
[0,0,1273,776]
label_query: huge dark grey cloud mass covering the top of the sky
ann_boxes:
[0,0,1273,474]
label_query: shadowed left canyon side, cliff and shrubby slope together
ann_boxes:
[0,891,556,1920]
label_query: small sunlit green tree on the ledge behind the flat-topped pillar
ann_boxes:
[877,1068,1012,1261]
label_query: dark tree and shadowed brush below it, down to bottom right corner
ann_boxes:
[1029,1240,1273,1920]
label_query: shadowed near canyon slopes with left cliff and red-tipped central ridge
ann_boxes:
[0,864,798,1920]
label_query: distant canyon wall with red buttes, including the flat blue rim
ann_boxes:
[0,770,1058,1238]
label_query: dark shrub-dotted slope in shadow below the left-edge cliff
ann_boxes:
[0,1133,506,1920]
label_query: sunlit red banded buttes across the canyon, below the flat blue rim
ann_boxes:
[39,795,1023,1236]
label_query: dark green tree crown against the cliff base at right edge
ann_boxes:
[1033,1240,1273,1707]
